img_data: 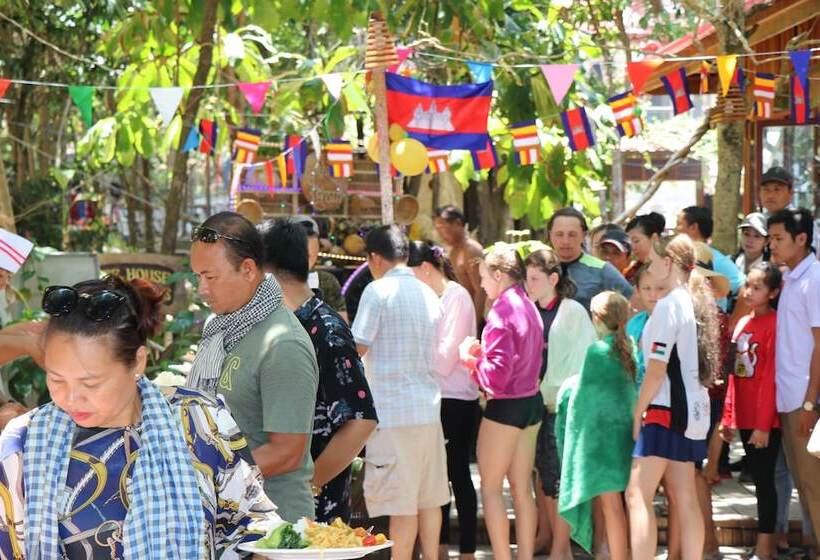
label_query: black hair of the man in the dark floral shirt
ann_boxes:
[257,219,310,282]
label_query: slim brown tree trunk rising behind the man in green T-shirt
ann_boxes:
[162,0,218,254]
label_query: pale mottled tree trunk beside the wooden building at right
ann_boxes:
[712,0,746,254]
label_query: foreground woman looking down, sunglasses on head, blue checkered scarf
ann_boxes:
[0,276,280,560]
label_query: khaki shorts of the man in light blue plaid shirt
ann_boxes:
[364,422,450,517]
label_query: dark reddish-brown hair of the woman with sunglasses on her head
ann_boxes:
[46,275,166,367]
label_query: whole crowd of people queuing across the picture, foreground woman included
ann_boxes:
[0,164,820,560]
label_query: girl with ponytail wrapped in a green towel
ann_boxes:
[556,292,637,560]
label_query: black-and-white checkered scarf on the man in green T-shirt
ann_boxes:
[185,274,282,394]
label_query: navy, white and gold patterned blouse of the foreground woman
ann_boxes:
[0,387,277,560]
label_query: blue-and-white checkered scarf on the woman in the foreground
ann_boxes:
[23,378,205,560]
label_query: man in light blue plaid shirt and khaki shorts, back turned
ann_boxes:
[352,226,450,560]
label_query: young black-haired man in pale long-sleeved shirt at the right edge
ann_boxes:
[768,208,820,537]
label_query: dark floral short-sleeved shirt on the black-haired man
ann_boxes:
[295,297,376,522]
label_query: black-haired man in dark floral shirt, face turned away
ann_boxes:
[260,220,377,522]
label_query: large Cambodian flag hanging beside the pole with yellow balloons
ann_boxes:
[386,72,493,150]
